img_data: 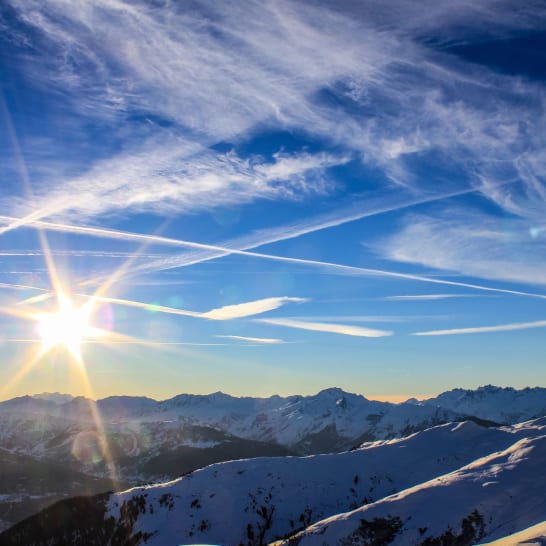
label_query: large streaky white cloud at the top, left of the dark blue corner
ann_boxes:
[5,0,391,136]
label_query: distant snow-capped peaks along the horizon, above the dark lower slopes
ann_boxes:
[4,386,546,464]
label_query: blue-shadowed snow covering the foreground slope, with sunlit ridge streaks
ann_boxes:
[100,422,546,546]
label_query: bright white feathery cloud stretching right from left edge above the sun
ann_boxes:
[0,143,349,226]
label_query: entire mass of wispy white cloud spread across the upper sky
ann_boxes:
[5,0,545,229]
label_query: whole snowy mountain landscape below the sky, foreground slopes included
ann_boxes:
[0,386,546,546]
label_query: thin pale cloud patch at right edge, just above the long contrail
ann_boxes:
[373,208,546,285]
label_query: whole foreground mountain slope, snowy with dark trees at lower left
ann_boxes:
[0,419,546,546]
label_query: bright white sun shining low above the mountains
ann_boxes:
[36,293,100,354]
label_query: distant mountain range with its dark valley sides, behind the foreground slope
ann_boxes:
[0,386,546,529]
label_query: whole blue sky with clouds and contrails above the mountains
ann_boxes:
[0,0,546,400]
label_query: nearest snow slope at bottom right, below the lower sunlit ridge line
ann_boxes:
[279,435,546,546]
